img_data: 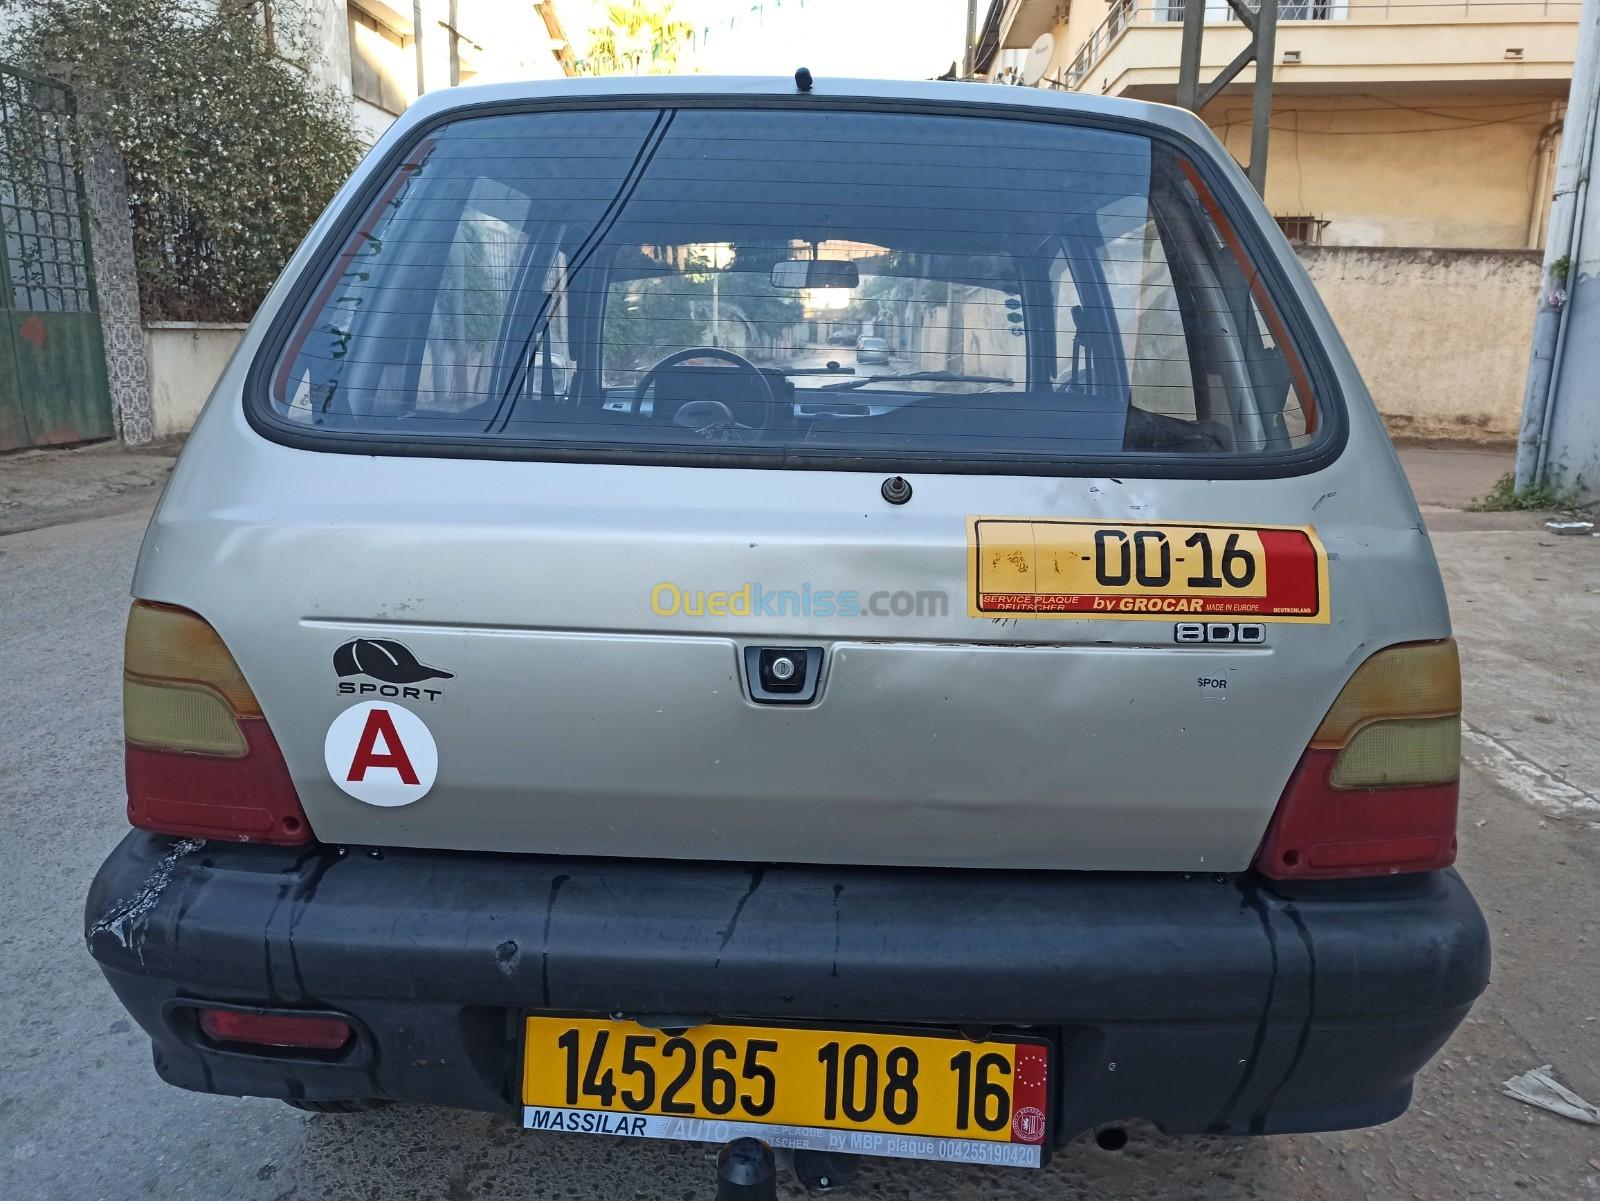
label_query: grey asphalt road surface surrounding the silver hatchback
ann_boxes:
[0,467,1600,1201]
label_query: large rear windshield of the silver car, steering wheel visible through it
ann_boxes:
[262,107,1326,470]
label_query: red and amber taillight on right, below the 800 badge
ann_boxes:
[1254,638,1461,880]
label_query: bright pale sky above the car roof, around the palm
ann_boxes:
[560,0,989,80]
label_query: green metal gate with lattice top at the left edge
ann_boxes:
[0,64,115,451]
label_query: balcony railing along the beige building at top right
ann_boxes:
[1040,0,1581,91]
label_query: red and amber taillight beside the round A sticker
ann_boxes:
[122,601,310,846]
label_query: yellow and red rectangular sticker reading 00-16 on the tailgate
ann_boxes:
[966,517,1330,624]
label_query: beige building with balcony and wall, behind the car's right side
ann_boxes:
[976,0,1579,438]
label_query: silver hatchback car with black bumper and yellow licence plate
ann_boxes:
[86,78,1488,1183]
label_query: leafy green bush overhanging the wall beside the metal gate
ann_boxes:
[0,0,362,321]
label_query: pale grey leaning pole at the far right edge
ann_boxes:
[1515,0,1600,502]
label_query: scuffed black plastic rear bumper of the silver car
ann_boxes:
[86,832,1490,1140]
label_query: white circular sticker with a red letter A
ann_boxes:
[322,700,438,808]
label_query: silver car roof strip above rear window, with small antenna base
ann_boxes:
[390,73,1211,144]
